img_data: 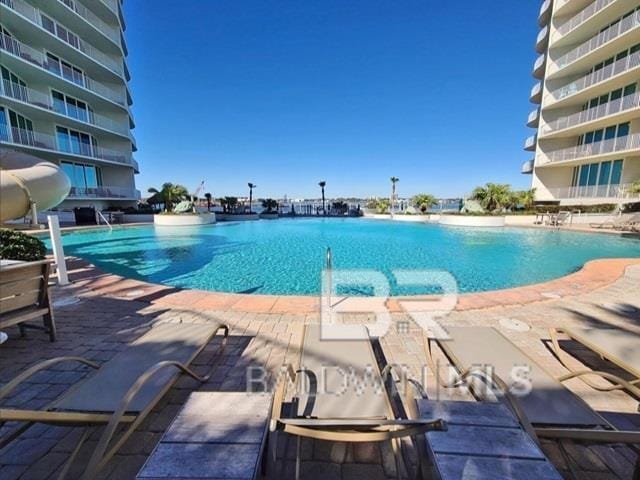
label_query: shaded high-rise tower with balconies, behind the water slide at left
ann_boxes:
[0,0,140,208]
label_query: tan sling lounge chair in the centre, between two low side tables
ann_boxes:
[270,325,446,476]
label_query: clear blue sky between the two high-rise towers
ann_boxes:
[125,0,540,198]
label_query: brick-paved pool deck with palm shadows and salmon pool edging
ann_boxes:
[0,259,640,480]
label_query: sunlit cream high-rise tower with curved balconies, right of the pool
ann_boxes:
[522,0,640,205]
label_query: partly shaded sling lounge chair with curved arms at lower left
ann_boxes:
[0,323,229,480]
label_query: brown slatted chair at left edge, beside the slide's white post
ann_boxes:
[0,260,56,342]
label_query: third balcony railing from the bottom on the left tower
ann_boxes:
[0,80,129,136]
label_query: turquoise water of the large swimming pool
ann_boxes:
[50,219,640,295]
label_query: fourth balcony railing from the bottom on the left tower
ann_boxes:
[0,31,126,106]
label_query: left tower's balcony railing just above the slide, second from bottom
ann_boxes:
[0,125,137,167]
